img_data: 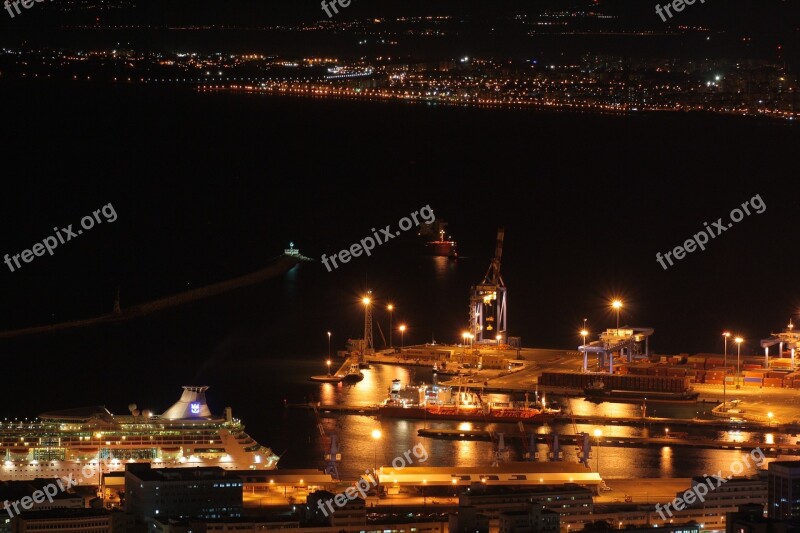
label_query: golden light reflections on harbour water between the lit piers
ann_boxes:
[304,365,780,479]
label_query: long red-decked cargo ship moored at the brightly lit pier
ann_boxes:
[378,379,554,422]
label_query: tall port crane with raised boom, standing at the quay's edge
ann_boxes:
[469,228,508,344]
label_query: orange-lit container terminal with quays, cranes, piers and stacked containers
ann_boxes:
[286,228,800,532]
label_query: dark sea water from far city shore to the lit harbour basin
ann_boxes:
[0,82,798,477]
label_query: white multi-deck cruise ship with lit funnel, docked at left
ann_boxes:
[0,386,279,485]
